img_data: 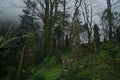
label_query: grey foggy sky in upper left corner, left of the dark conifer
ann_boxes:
[0,0,24,21]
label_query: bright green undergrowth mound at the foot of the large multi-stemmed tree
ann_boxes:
[28,56,62,80]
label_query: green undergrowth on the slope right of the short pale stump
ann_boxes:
[58,44,120,80]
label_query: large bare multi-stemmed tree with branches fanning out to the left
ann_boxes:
[21,0,60,54]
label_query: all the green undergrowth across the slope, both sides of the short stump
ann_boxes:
[28,44,120,80]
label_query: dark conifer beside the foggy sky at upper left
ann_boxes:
[20,0,37,34]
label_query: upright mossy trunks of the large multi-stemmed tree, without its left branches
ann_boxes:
[43,0,59,55]
